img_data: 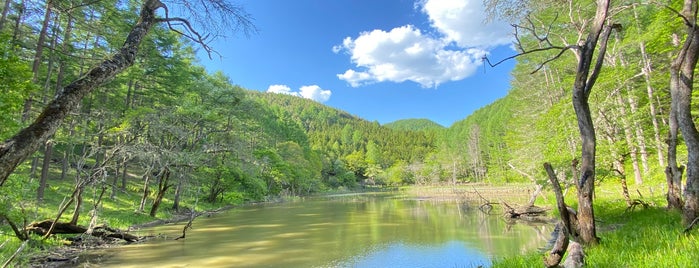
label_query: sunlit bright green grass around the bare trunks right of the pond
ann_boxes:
[493,180,699,268]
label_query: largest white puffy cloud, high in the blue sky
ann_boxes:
[333,0,511,87]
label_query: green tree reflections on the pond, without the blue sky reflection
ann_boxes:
[91,196,549,267]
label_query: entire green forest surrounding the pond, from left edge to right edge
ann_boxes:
[0,0,697,264]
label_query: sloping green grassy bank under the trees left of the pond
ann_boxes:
[0,172,243,267]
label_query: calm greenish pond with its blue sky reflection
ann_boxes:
[83,194,552,267]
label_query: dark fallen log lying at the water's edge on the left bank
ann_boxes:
[26,220,141,242]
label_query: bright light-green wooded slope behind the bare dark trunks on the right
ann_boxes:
[440,2,680,186]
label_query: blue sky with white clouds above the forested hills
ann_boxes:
[194,0,514,127]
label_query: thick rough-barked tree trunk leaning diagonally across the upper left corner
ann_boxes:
[0,0,164,186]
